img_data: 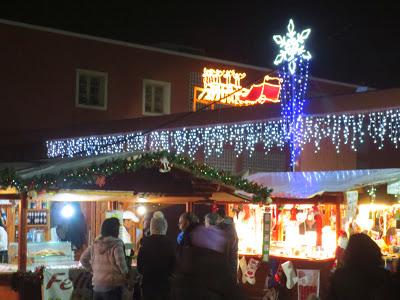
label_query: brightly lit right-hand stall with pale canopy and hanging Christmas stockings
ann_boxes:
[238,169,400,299]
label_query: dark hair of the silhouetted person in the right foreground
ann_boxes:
[344,233,383,269]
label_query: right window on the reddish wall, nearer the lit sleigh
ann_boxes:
[143,79,171,115]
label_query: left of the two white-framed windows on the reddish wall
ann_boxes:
[75,69,108,110]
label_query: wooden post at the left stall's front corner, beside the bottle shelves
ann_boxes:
[18,192,28,272]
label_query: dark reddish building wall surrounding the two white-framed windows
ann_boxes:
[0,22,354,131]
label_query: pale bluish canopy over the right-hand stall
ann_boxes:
[247,169,400,199]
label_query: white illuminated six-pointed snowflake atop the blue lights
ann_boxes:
[273,19,311,74]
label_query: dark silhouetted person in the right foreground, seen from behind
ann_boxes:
[328,233,390,300]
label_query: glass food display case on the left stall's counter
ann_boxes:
[8,242,74,267]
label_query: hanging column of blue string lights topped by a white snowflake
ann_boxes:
[273,19,311,168]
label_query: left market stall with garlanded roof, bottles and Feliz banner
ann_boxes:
[0,152,270,299]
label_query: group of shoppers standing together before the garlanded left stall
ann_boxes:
[80,211,242,300]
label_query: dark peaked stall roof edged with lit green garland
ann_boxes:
[0,151,270,204]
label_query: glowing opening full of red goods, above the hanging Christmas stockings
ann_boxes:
[230,204,337,260]
